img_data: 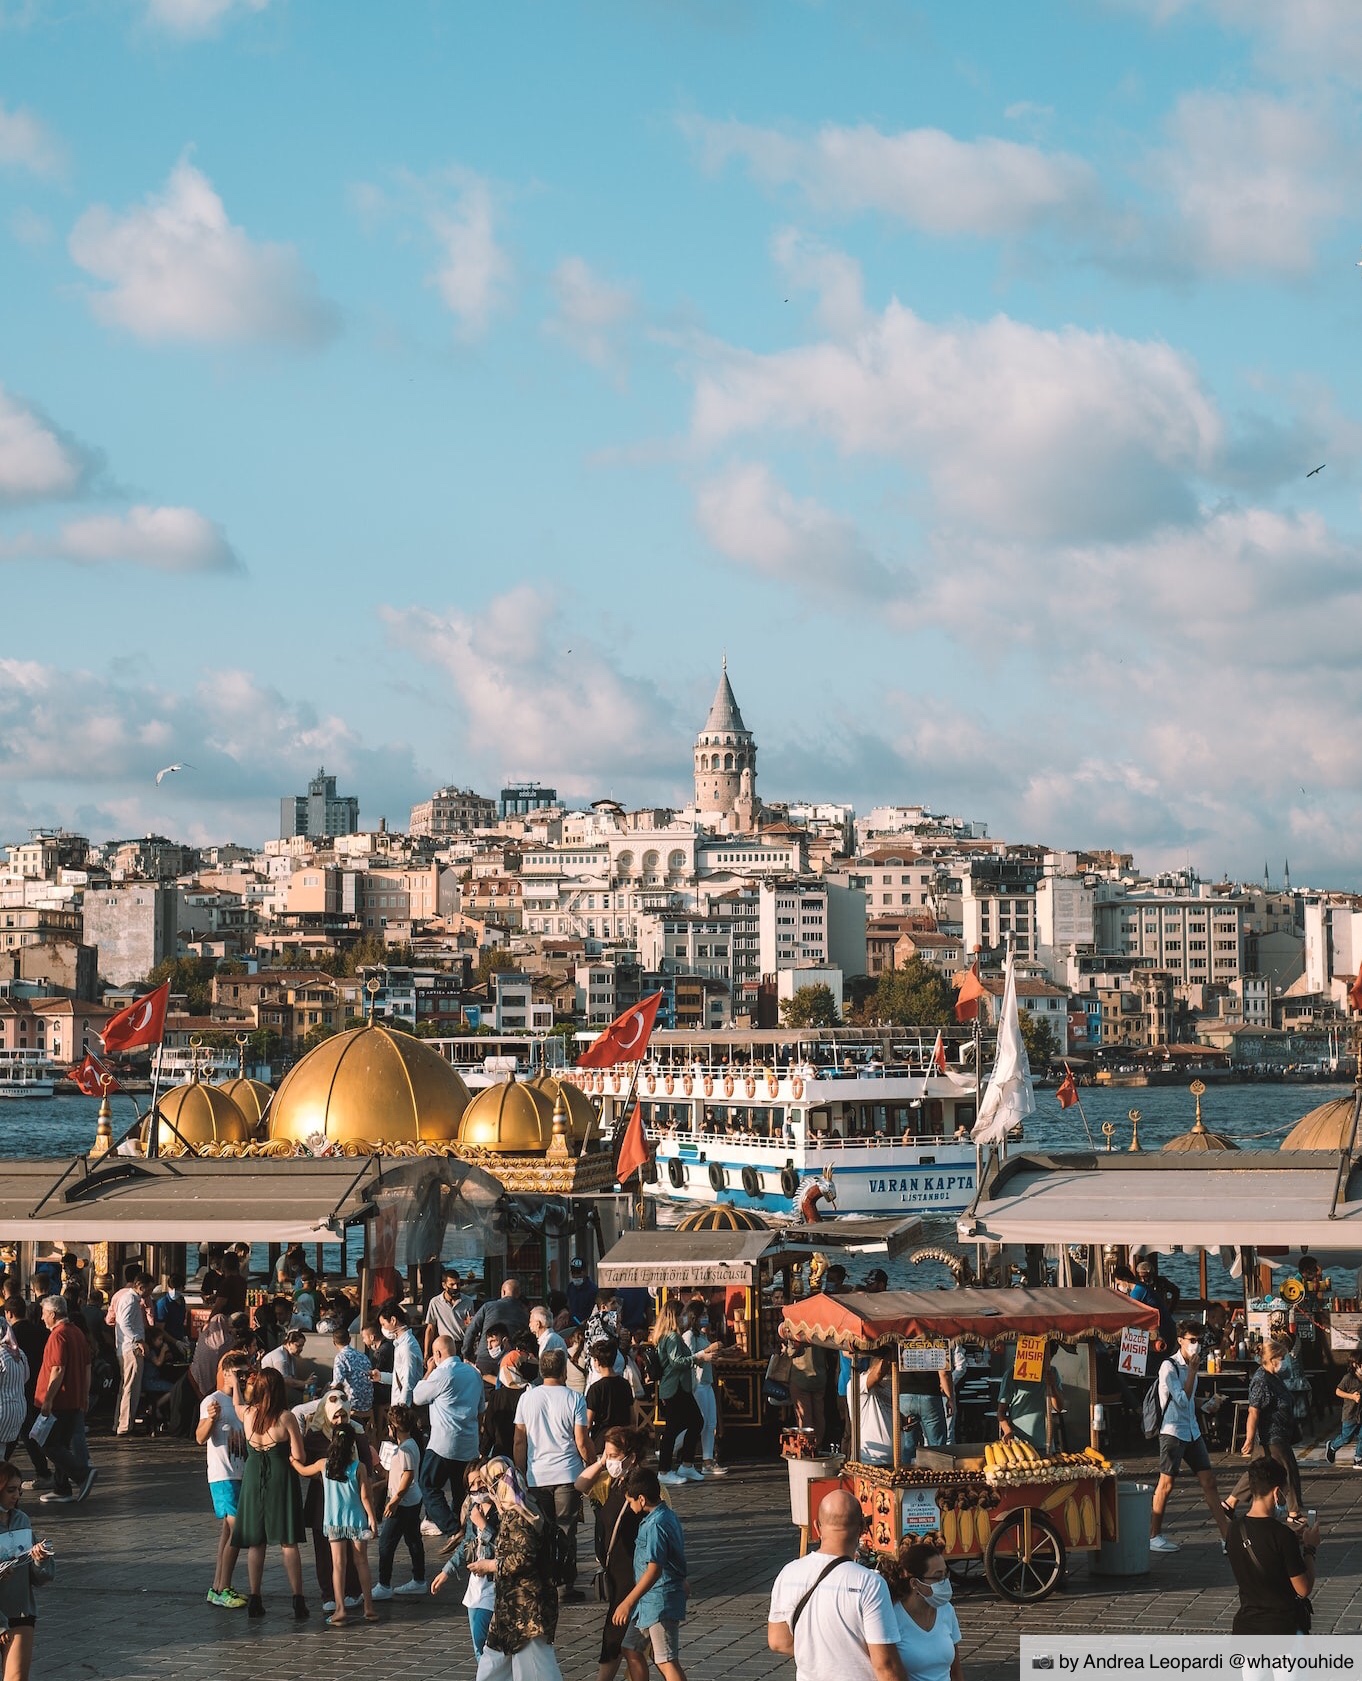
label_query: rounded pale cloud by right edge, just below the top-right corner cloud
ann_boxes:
[1145,92,1352,276]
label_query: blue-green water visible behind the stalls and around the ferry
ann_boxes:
[0,1084,1352,1298]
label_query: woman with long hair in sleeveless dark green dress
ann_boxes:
[235,1370,308,1622]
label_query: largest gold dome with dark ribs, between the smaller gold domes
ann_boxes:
[269,1022,467,1145]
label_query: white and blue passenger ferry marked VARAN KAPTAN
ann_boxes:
[567,1027,979,1219]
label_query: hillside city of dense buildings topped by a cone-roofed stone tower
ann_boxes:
[0,662,1362,1074]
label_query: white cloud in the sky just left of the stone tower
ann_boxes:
[383,585,689,797]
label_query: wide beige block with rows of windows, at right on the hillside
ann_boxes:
[1095,883,1244,985]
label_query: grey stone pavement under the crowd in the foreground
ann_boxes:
[24,1439,1362,1681]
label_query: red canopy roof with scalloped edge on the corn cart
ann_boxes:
[784,1288,1159,1348]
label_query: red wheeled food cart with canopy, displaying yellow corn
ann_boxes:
[785,1288,1159,1604]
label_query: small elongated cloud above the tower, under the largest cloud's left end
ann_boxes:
[696,462,910,607]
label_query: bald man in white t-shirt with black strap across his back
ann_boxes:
[767,1489,906,1681]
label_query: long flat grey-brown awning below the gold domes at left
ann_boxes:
[0,1155,499,1244]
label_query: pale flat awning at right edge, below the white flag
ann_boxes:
[958,1150,1362,1249]
